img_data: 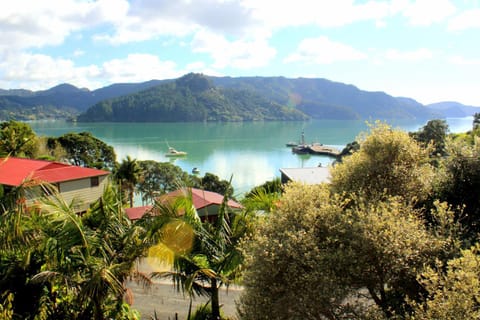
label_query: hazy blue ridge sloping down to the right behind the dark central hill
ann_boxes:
[212,77,438,119]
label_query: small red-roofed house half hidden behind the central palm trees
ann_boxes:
[126,188,243,221]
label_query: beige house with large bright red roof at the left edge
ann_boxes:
[0,157,110,213]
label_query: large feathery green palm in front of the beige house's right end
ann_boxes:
[32,186,144,320]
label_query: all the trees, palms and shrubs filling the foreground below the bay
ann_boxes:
[0,114,480,320]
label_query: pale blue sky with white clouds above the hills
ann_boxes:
[0,0,480,106]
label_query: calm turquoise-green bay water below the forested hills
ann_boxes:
[29,118,472,195]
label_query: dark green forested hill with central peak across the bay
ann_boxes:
[78,74,308,122]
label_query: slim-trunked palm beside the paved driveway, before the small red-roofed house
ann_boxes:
[143,189,249,319]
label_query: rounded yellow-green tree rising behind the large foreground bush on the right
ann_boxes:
[331,123,434,200]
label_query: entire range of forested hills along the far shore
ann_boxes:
[0,74,472,121]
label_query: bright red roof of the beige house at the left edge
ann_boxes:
[0,157,110,186]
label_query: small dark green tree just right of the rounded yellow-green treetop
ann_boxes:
[412,119,448,156]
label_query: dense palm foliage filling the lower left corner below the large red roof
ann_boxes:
[0,182,145,320]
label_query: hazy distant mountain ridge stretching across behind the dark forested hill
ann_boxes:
[0,74,480,121]
